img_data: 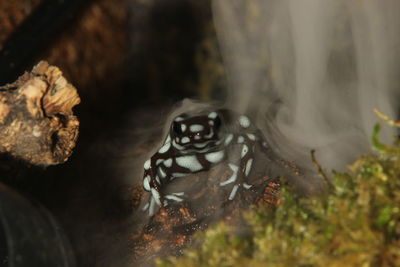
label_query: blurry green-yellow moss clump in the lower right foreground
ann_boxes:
[157,122,400,267]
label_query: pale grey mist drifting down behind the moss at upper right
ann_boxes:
[213,0,400,170]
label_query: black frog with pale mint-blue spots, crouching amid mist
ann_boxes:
[143,108,269,216]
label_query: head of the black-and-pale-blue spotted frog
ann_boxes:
[170,111,221,150]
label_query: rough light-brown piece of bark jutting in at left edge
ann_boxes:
[0,61,80,166]
